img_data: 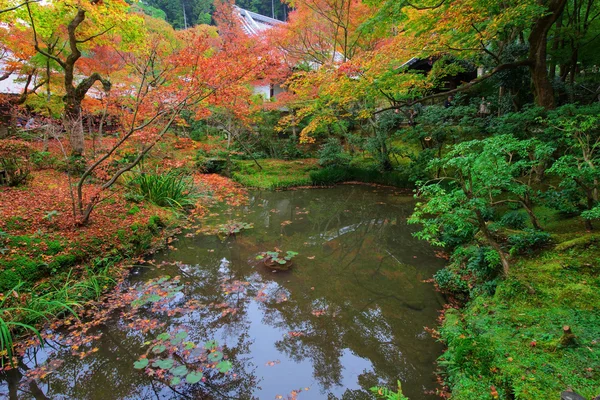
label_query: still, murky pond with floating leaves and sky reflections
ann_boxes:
[0,185,444,400]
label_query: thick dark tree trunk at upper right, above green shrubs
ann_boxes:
[529,0,567,109]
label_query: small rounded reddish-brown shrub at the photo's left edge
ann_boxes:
[0,139,34,186]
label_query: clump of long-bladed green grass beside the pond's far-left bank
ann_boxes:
[128,171,198,208]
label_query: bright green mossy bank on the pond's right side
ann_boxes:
[440,231,600,400]
